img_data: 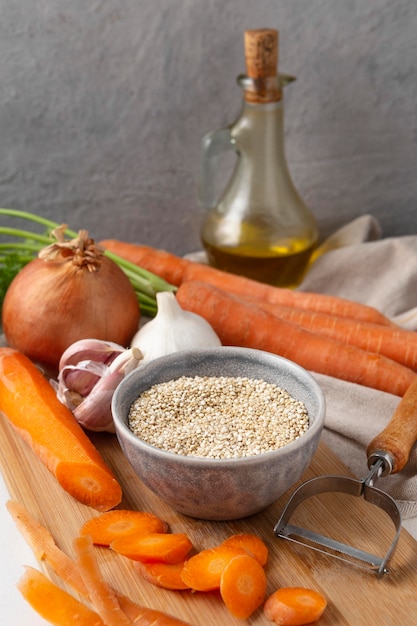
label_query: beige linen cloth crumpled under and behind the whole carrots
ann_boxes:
[299,215,417,538]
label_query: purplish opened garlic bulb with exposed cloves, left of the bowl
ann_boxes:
[51,339,142,433]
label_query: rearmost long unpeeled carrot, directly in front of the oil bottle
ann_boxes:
[100,239,392,325]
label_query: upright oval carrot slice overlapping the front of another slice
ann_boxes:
[220,554,266,619]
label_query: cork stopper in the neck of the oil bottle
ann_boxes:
[245,28,281,102]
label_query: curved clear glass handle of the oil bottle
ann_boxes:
[198,127,236,209]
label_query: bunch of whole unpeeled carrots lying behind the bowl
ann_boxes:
[101,239,417,396]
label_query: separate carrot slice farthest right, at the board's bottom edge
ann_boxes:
[264,587,327,626]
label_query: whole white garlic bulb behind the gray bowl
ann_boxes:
[130,291,221,363]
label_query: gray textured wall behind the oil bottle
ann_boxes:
[0,0,417,253]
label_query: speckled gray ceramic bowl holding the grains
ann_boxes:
[112,347,325,521]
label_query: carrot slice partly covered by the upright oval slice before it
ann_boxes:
[181,544,247,591]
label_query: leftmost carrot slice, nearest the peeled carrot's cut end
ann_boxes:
[80,509,168,546]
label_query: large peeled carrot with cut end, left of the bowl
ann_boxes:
[0,348,122,511]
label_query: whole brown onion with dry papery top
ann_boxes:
[2,225,140,369]
